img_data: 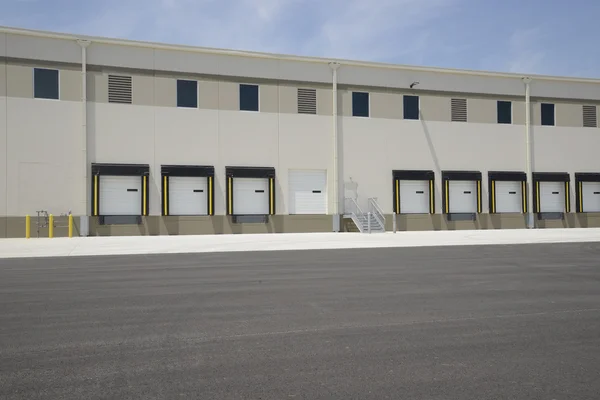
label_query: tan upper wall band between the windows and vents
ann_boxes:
[47,65,596,127]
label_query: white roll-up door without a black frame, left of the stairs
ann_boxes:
[289,170,327,214]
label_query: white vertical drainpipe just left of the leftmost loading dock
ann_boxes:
[77,40,91,236]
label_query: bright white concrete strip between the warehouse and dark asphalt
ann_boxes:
[0,228,600,258]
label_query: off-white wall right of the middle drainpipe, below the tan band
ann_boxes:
[341,117,600,213]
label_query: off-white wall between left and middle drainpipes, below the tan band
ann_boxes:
[88,104,333,215]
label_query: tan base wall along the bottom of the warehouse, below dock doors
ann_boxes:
[0,213,600,239]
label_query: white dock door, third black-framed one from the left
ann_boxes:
[233,178,269,215]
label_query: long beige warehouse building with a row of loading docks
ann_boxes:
[0,28,600,237]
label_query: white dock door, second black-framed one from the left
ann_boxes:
[169,176,208,215]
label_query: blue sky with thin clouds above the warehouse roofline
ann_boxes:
[0,0,600,78]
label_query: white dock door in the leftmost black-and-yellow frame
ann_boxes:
[99,175,142,215]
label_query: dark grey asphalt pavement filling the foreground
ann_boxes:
[0,243,600,400]
